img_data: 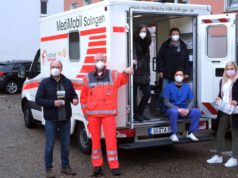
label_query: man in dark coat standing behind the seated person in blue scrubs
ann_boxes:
[156,27,189,112]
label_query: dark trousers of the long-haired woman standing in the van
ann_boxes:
[133,83,151,115]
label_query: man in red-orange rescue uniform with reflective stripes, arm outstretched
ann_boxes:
[80,53,133,176]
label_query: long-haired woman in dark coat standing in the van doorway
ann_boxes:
[133,24,151,122]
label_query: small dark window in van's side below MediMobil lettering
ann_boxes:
[69,32,80,61]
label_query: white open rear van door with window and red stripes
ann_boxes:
[197,14,236,118]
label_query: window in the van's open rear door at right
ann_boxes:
[207,26,227,58]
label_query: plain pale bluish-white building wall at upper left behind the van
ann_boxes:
[0,0,64,61]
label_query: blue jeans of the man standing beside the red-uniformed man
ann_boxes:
[45,120,70,170]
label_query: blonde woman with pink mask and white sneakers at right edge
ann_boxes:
[207,61,238,167]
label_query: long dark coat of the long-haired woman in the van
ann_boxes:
[133,40,150,84]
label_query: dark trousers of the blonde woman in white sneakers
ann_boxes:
[217,113,238,158]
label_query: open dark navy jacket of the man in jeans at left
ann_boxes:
[36,75,78,121]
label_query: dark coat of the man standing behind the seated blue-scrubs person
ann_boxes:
[156,39,189,80]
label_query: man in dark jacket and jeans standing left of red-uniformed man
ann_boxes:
[36,60,78,178]
